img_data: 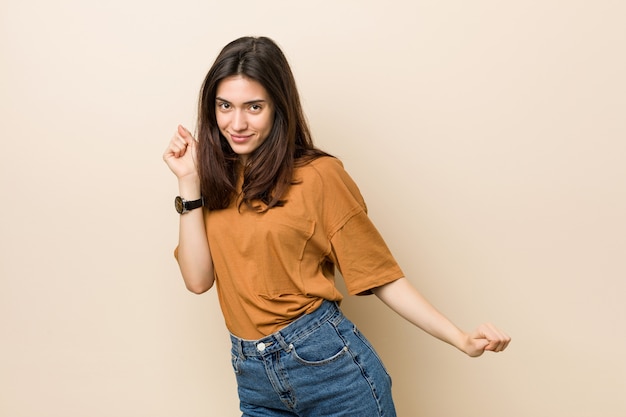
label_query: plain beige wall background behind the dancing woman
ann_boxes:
[0,0,626,417]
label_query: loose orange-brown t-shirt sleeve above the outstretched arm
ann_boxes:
[312,159,404,295]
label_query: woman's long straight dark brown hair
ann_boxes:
[198,37,328,210]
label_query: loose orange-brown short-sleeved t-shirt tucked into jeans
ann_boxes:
[197,157,403,340]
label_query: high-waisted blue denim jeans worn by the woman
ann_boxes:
[231,301,396,417]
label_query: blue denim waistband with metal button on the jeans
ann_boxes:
[230,300,343,358]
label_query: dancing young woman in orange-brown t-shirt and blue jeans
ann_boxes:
[163,37,510,417]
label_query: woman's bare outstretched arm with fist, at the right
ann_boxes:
[373,278,511,357]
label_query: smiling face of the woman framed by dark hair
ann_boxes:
[215,75,274,163]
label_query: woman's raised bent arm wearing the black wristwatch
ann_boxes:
[163,126,215,294]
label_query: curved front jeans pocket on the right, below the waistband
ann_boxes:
[291,322,348,366]
